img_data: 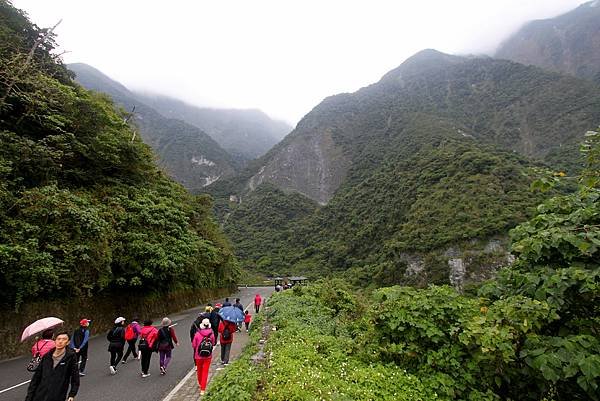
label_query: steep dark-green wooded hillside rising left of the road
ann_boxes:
[0,1,237,307]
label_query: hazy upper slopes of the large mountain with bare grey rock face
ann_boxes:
[247,50,600,204]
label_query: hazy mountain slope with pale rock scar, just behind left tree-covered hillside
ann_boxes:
[68,63,237,192]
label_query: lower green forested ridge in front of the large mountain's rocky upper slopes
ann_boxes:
[220,120,542,285]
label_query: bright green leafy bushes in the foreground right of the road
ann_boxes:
[211,131,600,401]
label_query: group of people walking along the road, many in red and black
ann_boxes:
[26,294,262,401]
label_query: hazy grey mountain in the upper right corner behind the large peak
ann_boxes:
[496,0,600,83]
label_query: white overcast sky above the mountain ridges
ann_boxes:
[13,0,584,124]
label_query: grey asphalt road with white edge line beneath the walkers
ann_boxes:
[0,287,274,401]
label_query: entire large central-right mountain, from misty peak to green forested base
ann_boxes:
[212,50,600,285]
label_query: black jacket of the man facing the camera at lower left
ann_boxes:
[25,349,79,401]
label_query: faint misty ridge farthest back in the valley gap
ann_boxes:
[136,92,292,162]
